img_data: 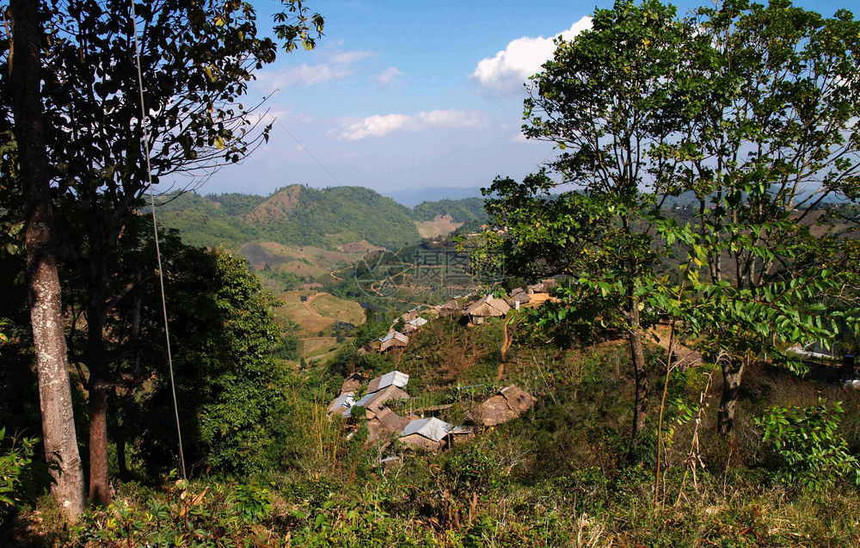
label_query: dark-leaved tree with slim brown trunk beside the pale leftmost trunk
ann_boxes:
[3,0,323,502]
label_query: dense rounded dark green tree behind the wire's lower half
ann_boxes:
[88,229,287,475]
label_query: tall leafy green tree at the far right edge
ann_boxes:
[653,0,860,434]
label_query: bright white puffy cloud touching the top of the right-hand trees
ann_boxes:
[472,16,591,92]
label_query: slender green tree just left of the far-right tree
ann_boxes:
[490,0,691,446]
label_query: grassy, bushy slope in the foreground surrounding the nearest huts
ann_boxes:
[45,312,860,546]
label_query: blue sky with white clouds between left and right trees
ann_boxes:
[193,0,860,194]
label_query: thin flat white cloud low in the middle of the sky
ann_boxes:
[337,110,484,141]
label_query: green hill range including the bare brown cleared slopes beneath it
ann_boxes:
[158,185,486,287]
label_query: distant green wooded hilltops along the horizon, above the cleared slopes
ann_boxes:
[159,185,486,251]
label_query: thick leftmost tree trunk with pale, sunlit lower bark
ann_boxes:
[10,0,84,522]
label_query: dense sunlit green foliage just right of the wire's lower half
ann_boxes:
[140,247,285,473]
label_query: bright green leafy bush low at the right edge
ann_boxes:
[756,401,860,488]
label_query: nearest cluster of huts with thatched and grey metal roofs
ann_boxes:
[328,371,535,451]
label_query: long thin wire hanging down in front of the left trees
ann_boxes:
[129,0,188,479]
